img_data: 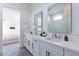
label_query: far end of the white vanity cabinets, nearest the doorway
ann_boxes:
[24,35,39,56]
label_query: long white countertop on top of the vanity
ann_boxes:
[31,35,79,52]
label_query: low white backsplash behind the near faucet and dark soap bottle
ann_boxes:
[48,33,79,42]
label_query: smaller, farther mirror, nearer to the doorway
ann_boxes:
[34,12,43,34]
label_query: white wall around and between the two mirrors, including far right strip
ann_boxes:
[30,3,79,35]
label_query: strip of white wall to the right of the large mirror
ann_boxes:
[72,3,79,35]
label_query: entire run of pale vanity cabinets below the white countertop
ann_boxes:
[24,35,79,56]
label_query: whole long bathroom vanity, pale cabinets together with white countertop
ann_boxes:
[25,34,79,56]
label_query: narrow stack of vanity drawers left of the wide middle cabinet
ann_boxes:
[32,38,39,56]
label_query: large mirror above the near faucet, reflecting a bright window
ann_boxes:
[48,3,72,33]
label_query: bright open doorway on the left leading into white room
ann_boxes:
[2,7,20,55]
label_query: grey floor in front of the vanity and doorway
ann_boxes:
[3,43,32,56]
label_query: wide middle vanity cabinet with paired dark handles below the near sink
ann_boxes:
[39,41,63,56]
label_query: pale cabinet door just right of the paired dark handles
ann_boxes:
[48,44,63,56]
